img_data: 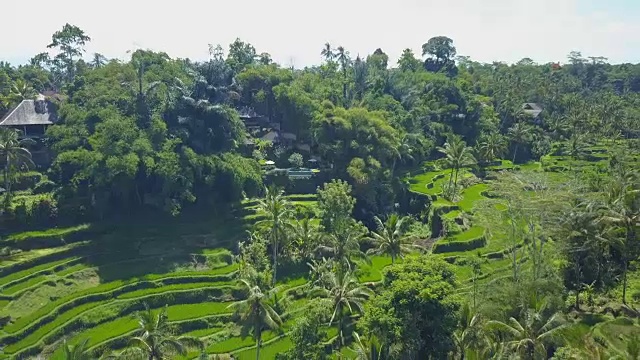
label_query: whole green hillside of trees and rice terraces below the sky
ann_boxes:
[0,24,640,360]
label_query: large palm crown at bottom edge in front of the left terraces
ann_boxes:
[121,304,204,360]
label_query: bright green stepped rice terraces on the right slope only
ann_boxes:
[409,142,628,283]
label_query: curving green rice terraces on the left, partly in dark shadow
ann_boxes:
[0,195,391,359]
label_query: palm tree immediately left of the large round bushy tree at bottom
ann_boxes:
[313,271,373,345]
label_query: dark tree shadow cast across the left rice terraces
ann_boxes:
[79,207,247,283]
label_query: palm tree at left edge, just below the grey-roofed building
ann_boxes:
[0,128,33,199]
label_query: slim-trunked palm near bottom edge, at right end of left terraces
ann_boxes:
[229,279,282,360]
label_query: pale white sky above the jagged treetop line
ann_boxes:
[0,0,640,67]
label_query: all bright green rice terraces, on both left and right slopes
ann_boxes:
[0,144,632,359]
